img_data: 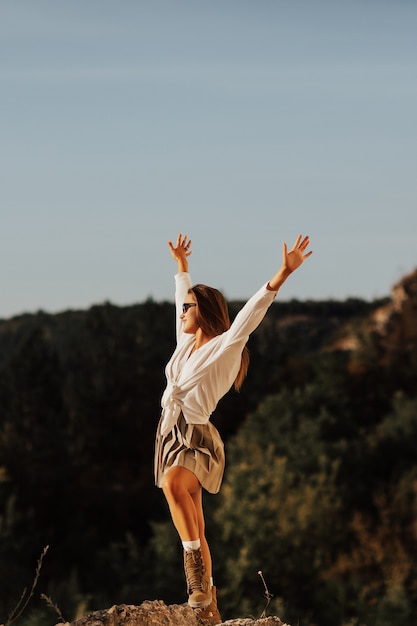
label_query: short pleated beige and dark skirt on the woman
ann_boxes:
[155,412,225,493]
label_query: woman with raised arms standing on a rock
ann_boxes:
[155,233,312,615]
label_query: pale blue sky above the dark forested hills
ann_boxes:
[0,0,417,318]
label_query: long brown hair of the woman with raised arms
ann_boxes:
[188,284,249,391]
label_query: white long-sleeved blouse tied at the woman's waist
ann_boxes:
[161,272,277,436]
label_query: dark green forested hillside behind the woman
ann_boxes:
[0,284,417,626]
